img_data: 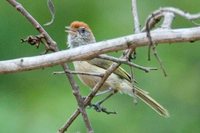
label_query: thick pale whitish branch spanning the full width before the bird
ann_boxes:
[0,27,200,74]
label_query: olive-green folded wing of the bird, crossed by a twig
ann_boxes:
[87,58,131,82]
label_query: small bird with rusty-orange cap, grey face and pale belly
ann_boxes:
[66,21,169,117]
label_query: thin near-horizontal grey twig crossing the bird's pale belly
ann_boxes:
[53,70,103,77]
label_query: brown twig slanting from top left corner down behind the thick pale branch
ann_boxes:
[7,0,93,133]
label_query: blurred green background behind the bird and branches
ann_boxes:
[0,0,200,133]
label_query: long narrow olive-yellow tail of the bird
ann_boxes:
[134,87,169,117]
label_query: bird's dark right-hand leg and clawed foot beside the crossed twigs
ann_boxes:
[90,89,117,114]
